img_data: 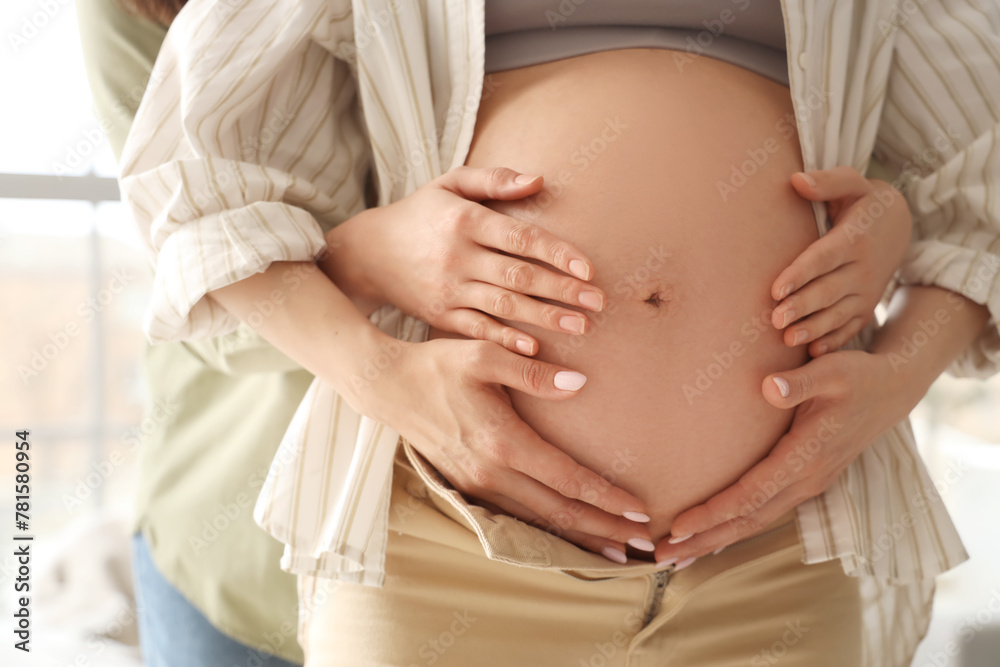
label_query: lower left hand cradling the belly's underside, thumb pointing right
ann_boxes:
[358,339,653,562]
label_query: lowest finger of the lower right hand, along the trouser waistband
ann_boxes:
[654,487,805,565]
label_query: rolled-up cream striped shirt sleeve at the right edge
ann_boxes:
[875,0,1000,377]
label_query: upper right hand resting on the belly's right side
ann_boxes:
[771,167,913,357]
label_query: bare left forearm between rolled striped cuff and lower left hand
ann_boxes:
[209,262,390,409]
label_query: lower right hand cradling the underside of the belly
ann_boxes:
[656,350,923,564]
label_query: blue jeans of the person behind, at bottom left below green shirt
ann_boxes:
[132,533,298,667]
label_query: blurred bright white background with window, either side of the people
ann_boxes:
[0,0,1000,667]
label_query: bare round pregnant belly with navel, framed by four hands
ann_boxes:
[431,49,817,539]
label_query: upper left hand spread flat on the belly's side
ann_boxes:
[320,166,605,355]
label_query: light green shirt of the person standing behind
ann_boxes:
[77,0,304,663]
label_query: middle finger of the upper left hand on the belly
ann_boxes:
[468,251,605,312]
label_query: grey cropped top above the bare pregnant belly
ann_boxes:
[486,0,788,86]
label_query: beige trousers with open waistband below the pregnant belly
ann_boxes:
[301,441,862,667]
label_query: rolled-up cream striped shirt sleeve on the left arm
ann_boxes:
[120,0,370,342]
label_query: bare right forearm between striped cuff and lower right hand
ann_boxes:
[869,286,989,407]
